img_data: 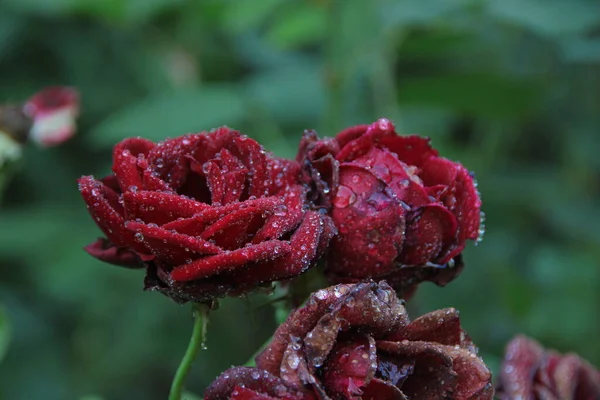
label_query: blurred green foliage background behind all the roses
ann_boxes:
[0,0,600,400]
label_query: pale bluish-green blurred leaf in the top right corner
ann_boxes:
[488,0,600,36]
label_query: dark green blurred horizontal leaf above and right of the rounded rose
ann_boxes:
[398,74,541,117]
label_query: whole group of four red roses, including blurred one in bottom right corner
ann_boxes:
[79,119,600,400]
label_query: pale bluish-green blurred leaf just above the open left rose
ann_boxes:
[90,86,245,146]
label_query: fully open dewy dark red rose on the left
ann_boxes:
[79,128,335,301]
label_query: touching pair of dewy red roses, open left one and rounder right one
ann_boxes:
[79,119,481,302]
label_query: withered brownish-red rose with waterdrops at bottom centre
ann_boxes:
[205,282,494,400]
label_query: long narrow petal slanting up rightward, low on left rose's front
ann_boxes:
[171,240,291,281]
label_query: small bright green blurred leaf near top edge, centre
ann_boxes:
[267,2,327,49]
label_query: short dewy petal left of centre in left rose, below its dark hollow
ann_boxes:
[123,190,210,225]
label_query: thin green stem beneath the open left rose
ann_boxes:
[169,303,209,400]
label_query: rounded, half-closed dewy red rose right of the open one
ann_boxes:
[297,118,481,295]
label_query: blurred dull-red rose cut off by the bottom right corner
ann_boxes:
[497,336,600,400]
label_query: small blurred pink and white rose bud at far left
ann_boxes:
[23,86,79,146]
